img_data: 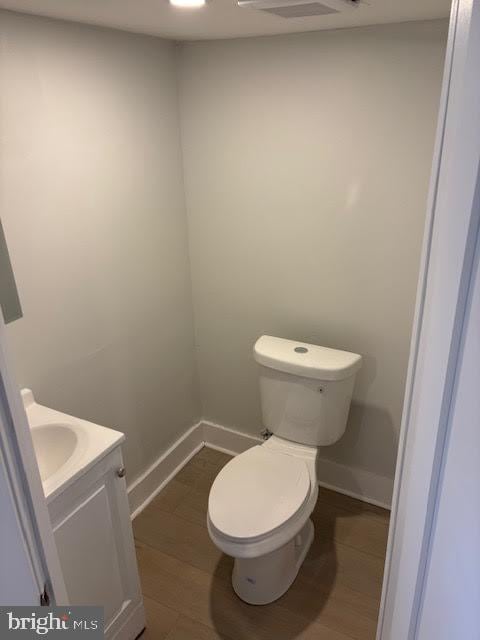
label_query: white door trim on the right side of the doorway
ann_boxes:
[377,0,480,640]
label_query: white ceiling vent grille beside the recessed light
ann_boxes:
[238,0,363,18]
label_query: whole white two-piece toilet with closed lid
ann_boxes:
[207,336,362,605]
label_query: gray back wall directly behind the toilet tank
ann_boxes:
[180,21,447,484]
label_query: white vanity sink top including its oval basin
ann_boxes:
[22,389,125,501]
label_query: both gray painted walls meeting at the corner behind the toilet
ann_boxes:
[0,12,447,496]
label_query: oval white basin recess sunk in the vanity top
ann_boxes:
[31,424,79,482]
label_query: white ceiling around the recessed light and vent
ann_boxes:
[0,0,450,40]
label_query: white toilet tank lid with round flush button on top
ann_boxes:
[253,336,362,380]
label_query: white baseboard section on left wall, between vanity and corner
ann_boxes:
[127,422,205,520]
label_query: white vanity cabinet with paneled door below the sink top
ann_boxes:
[48,446,145,640]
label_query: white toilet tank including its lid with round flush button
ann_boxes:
[254,336,362,446]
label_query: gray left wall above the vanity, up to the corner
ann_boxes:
[0,12,200,480]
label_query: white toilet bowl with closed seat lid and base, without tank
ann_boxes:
[207,436,318,604]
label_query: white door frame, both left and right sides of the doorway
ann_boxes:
[0,0,480,640]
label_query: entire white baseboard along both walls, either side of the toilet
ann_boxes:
[128,420,393,520]
